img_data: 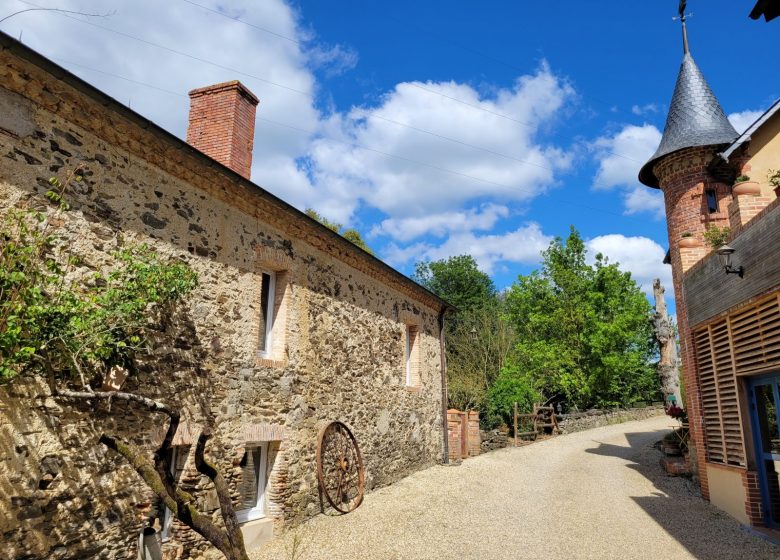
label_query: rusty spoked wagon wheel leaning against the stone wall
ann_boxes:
[317,422,366,513]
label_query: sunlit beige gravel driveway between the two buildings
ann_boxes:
[252,417,780,560]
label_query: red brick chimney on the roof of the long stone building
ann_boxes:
[187,80,259,179]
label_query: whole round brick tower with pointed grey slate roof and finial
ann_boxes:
[639,10,738,499]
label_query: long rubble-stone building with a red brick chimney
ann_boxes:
[0,34,447,560]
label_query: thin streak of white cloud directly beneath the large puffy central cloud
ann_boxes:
[371,204,509,242]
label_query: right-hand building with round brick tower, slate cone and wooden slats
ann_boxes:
[639,18,780,527]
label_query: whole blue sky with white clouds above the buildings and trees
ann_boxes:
[0,0,780,306]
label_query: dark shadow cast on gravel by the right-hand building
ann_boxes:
[586,430,780,560]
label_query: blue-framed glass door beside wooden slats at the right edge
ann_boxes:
[749,374,780,527]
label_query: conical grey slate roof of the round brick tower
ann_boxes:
[639,52,739,188]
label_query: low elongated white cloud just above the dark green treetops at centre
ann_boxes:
[384,222,552,274]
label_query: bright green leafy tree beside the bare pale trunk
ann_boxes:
[507,228,658,407]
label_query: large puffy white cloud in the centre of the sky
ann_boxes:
[308,64,573,221]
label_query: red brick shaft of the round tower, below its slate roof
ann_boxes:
[653,147,729,500]
